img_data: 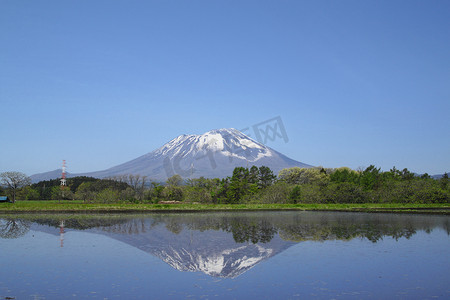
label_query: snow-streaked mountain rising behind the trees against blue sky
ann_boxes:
[31,129,311,182]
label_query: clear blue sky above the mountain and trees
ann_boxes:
[0,0,450,175]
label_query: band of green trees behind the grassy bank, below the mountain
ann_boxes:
[0,165,450,204]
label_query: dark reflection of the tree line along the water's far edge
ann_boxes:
[0,212,450,243]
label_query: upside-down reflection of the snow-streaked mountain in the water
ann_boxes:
[127,226,293,277]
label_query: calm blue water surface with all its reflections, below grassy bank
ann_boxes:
[0,212,450,299]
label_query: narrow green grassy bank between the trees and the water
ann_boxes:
[0,201,450,214]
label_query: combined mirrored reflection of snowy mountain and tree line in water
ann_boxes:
[0,212,450,278]
